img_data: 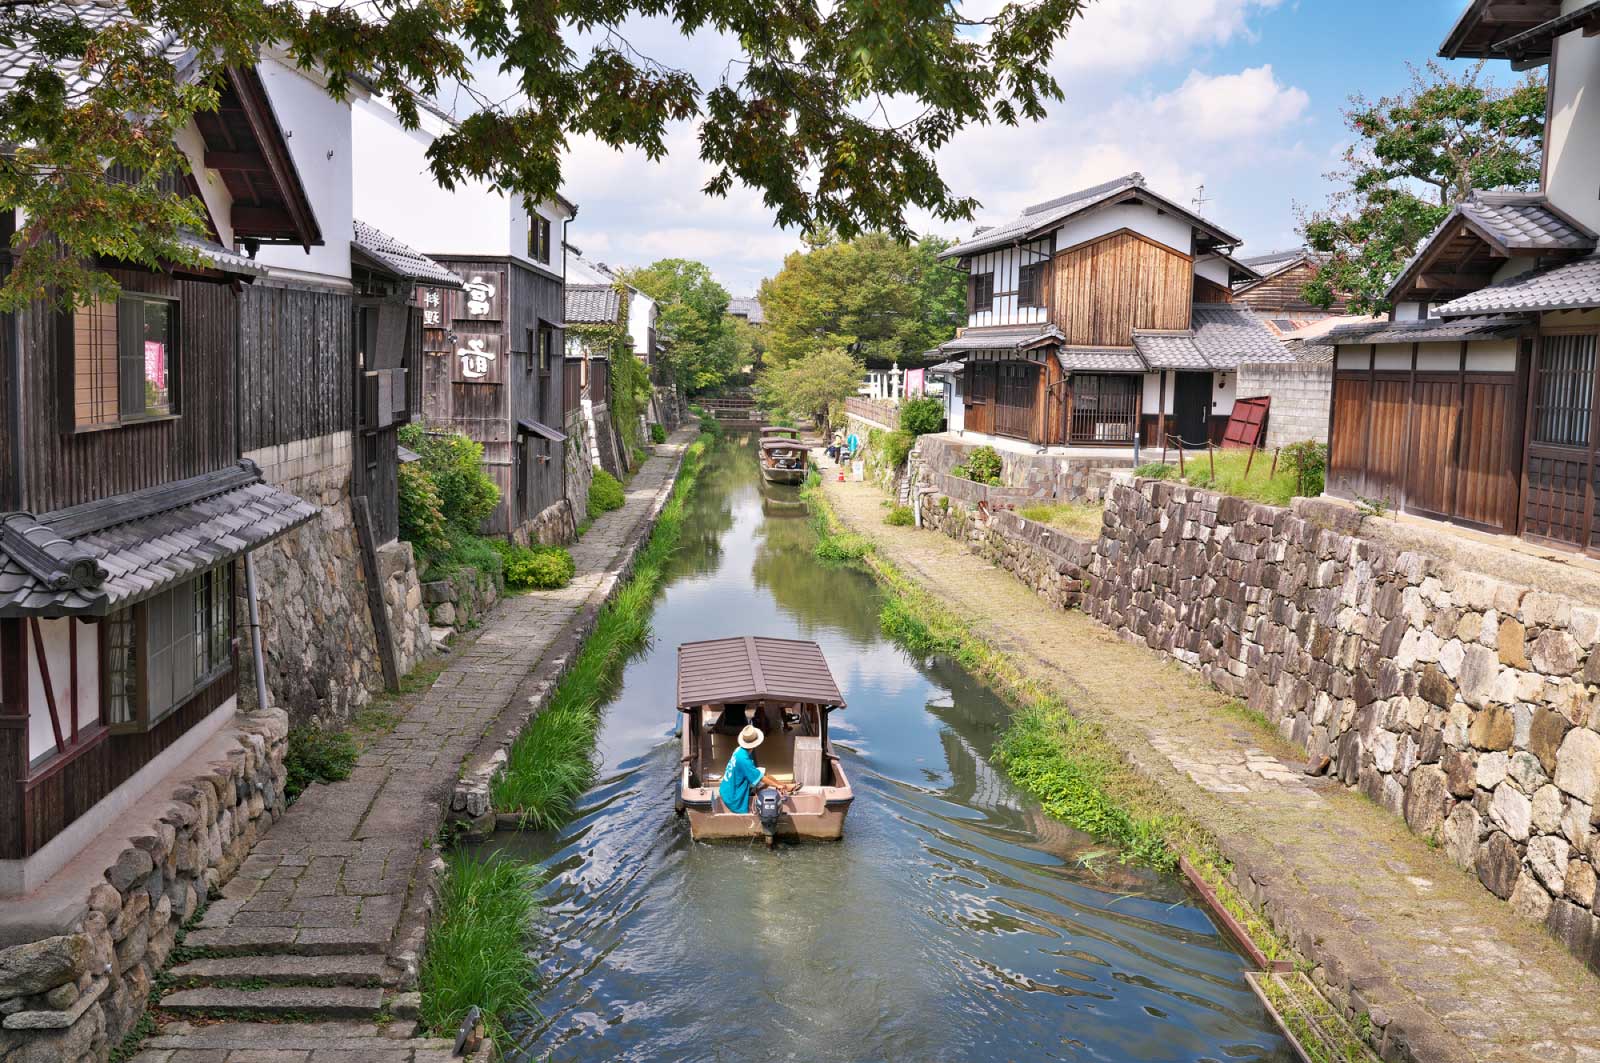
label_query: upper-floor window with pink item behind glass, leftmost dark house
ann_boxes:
[70,295,178,429]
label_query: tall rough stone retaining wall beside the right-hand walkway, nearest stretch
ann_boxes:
[1085,480,1600,967]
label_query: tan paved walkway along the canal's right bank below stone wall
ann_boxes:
[826,479,1600,1063]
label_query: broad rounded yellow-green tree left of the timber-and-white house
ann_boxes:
[760,232,966,365]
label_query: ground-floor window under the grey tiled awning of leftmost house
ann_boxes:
[101,565,234,732]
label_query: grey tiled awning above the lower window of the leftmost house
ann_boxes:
[0,461,318,618]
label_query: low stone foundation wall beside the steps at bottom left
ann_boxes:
[0,709,288,1063]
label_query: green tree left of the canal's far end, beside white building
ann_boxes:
[622,258,741,394]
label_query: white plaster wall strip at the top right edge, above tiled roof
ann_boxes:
[1544,8,1600,231]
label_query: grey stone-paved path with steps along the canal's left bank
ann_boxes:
[134,429,696,1063]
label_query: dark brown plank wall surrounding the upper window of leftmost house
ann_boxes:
[19,269,238,512]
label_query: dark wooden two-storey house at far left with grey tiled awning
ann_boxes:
[0,41,323,893]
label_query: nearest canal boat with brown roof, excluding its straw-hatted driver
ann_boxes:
[677,637,854,845]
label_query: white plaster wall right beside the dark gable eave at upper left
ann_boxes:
[256,58,354,280]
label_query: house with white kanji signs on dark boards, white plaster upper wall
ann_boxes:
[354,99,578,543]
